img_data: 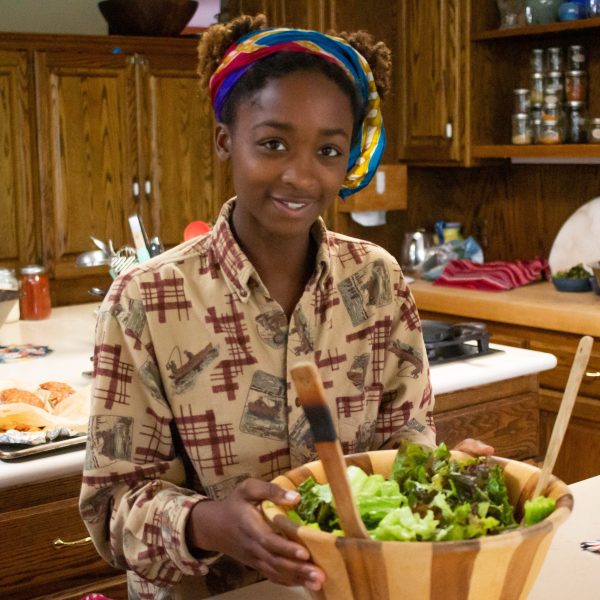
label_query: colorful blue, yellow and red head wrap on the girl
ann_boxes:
[210,28,385,198]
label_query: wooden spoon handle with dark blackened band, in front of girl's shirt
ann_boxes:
[291,362,370,539]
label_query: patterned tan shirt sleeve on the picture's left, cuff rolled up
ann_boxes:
[80,280,213,586]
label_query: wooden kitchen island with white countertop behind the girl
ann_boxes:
[0,304,556,600]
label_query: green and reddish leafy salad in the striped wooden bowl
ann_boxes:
[288,442,556,541]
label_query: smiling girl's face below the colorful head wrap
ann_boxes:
[216,71,353,244]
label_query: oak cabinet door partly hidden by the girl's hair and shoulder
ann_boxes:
[139,53,221,246]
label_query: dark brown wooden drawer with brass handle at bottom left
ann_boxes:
[0,498,122,600]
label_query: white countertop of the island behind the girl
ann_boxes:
[0,303,556,488]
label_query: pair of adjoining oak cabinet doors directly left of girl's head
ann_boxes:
[35,40,221,292]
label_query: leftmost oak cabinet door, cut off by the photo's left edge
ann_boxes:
[0,51,39,267]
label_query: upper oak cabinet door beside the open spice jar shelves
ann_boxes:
[399,0,468,163]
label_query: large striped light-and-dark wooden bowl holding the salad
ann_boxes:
[263,450,573,600]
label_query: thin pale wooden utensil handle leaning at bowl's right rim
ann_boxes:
[531,335,594,498]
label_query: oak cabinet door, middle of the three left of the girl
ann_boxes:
[36,49,138,278]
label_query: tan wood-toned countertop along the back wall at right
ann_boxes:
[409,279,600,337]
